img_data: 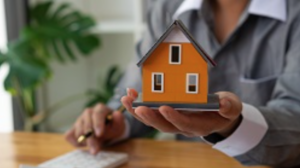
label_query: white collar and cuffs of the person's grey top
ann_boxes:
[120,0,287,157]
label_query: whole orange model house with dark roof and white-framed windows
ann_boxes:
[134,20,217,109]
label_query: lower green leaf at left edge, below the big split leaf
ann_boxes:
[4,41,51,94]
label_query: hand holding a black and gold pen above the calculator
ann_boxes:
[65,104,125,154]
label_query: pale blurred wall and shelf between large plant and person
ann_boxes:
[31,0,142,132]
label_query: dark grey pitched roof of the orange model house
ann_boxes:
[137,20,217,67]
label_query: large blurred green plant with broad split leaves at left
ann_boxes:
[0,1,100,130]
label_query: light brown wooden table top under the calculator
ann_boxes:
[0,132,263,168]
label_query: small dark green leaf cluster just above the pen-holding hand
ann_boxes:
[86,66,122,107]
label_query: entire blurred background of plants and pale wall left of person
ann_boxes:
[0,0,154,132]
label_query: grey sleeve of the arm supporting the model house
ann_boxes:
[236,17,300,167]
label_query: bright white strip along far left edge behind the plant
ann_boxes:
[0,0,13,132]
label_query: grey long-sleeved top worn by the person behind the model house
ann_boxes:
[108,0,300,167]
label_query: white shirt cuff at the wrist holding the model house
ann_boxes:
[213,103,268,157]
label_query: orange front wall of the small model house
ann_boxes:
[143,43,208,103]
